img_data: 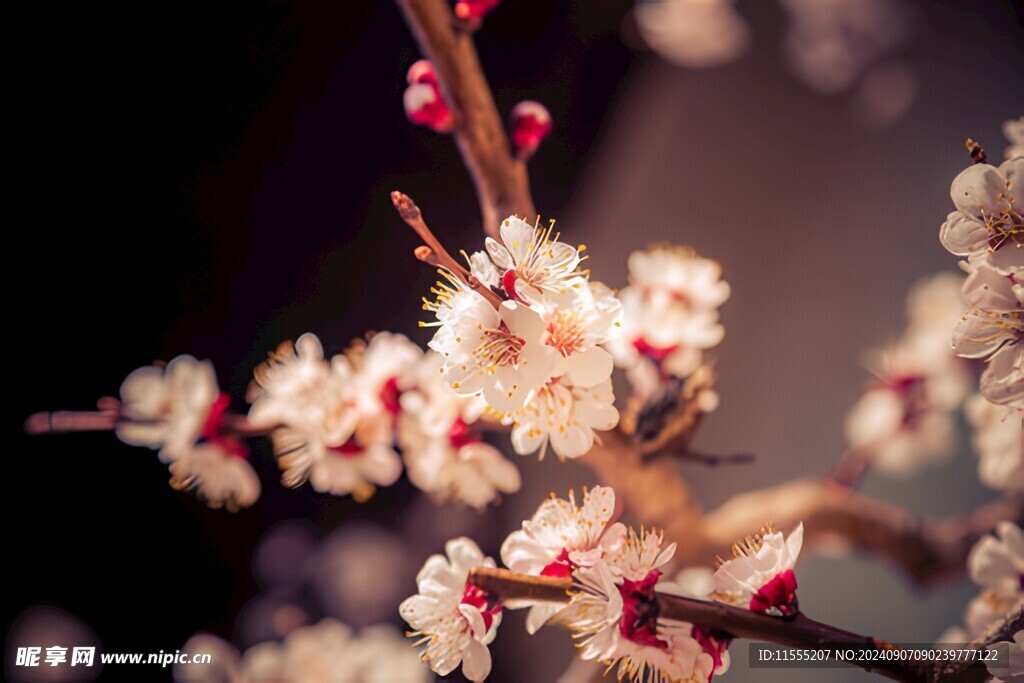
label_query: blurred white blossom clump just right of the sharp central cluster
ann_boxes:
[609,245,729,384]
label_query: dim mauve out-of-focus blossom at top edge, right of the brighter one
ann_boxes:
[782,0,911,93]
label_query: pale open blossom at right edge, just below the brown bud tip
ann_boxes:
[939,157,1024,280]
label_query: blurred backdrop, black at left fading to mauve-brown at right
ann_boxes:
[5,0,1024,681]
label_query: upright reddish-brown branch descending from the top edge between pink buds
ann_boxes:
[397,0,537,235]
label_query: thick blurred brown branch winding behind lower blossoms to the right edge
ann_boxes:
[584,432,1024,586]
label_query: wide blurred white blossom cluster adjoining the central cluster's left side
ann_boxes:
[249,332,519,508]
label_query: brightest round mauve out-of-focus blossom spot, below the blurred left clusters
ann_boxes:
[312,524,415,626]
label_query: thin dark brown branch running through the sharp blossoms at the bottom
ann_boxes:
[468,567,929,682]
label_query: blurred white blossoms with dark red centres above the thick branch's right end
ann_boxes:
[844,273,970,476]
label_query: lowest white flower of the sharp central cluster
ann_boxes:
[506,378,618,460]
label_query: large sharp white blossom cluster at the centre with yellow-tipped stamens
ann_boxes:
[421,216,622,458]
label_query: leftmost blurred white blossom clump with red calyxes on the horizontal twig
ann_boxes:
[115,355,260,511]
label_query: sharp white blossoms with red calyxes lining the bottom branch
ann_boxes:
[399,486,803,683]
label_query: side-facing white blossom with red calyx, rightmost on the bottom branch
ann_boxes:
[712,523,804,616]
